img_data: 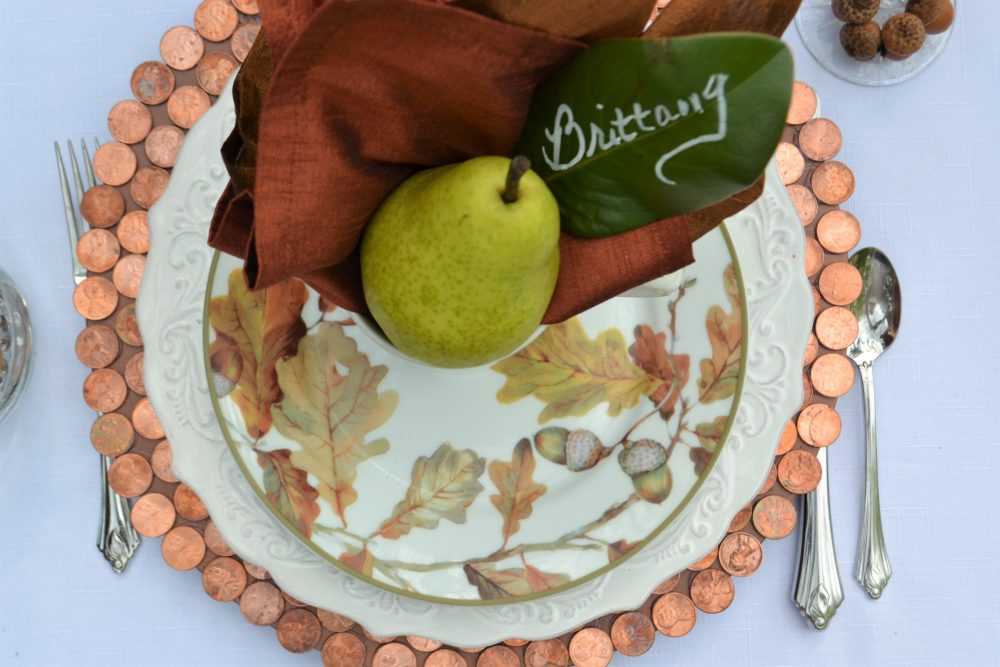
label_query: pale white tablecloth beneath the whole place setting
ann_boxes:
[0,0,1000,667]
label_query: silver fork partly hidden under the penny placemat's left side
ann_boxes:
[55,139,140,574]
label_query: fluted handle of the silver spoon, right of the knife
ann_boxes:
[854,361,892,600]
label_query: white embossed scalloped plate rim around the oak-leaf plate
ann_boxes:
[138,79,813,646]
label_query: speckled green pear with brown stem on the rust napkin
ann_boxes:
[361,157,559,368]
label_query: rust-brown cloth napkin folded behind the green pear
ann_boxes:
[209,0,798,322]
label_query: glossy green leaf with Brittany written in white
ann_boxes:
[518,33,793,237]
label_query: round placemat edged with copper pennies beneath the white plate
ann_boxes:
[74,0,860,667]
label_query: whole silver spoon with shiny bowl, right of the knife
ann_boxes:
[847,248,902,600]
